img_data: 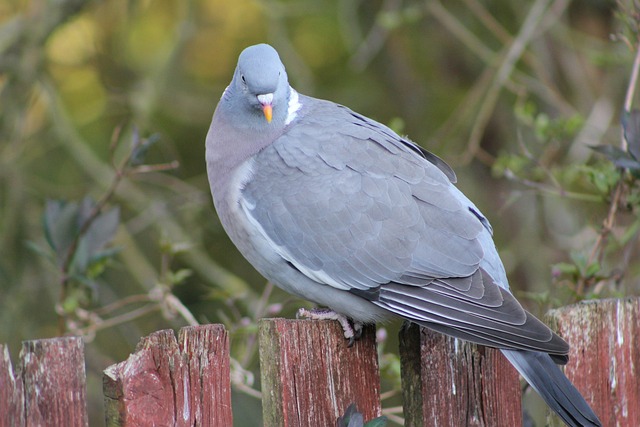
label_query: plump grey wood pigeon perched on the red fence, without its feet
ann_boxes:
[206,45,600,426]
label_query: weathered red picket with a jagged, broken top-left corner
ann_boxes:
[103,325,233,426]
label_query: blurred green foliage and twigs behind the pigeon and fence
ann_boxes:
[0,0,640,426]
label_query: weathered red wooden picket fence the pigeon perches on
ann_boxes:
[0,298,640,427]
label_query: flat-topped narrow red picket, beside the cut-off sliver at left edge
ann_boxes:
[20,337,89,427]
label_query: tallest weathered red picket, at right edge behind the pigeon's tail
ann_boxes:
[548,297,640,426]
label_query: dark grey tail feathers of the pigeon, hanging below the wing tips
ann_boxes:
[501,349,602,427]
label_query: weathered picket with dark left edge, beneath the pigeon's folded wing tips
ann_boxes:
[400,324,522,427]
